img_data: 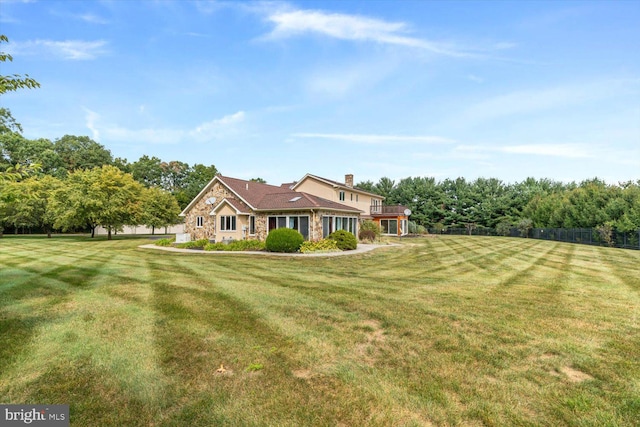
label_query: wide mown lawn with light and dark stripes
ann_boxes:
[0,236,640,426]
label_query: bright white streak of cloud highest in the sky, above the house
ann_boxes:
[266,9,480,57]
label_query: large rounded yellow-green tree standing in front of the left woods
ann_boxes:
[52,166,144,240]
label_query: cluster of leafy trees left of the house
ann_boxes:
[0,108,218,238]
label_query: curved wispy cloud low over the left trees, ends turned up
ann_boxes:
[84,108,245,144]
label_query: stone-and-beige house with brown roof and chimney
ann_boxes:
[180,174,406,242]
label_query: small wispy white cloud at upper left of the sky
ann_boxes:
[8,40,108,60]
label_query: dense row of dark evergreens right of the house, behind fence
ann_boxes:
[356,177,640,232]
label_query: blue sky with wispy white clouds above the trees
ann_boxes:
[0,0,640,184]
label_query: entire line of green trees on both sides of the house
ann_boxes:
[0,109,640,239]
